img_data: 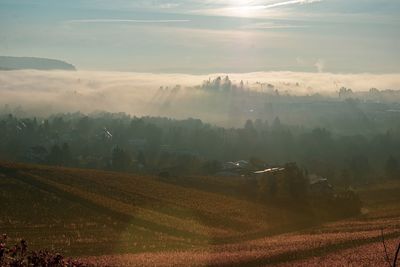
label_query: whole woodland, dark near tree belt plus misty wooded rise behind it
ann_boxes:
[0,76,400,188]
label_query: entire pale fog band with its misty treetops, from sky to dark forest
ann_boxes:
[0,71,400,130]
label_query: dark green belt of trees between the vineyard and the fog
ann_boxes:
[0,104,400,185]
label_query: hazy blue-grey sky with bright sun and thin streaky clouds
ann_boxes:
[0,0,400,73]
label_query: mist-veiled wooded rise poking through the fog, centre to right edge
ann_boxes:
[142,76,400,131]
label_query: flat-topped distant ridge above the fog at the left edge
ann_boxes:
[0,56,76,71]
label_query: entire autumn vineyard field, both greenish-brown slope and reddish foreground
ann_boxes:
[0,163,400,266]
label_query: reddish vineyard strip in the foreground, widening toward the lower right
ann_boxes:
[84,181,400,266]
